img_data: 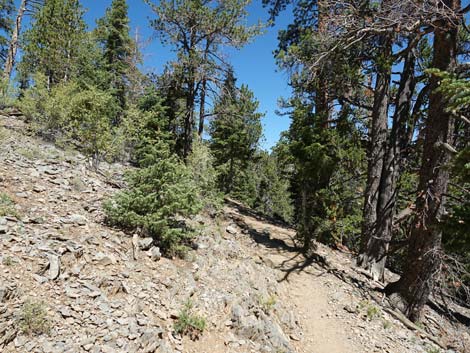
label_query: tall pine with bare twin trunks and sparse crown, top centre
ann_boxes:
[145,0,259,159]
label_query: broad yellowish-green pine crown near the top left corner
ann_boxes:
[19,0,86,88]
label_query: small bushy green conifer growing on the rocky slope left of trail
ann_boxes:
[105,112,201,254]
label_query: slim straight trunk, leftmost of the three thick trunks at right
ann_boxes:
[358,37,392,279]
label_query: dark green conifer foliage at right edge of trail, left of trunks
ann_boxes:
[286,99,365,250]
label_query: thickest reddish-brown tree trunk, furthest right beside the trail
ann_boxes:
[385,0,460,321]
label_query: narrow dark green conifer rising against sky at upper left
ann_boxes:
[96,0,136,110]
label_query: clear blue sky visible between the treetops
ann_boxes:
[81,0,290,149]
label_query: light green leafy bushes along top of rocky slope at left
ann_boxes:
[19,74,120,166]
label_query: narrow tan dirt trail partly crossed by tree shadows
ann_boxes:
[226,204,365,353]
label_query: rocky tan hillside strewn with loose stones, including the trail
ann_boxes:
[0,116,470,353]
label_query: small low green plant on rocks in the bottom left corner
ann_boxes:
[19,301,51,335]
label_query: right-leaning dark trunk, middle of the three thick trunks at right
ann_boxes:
[361,48,416,281]
